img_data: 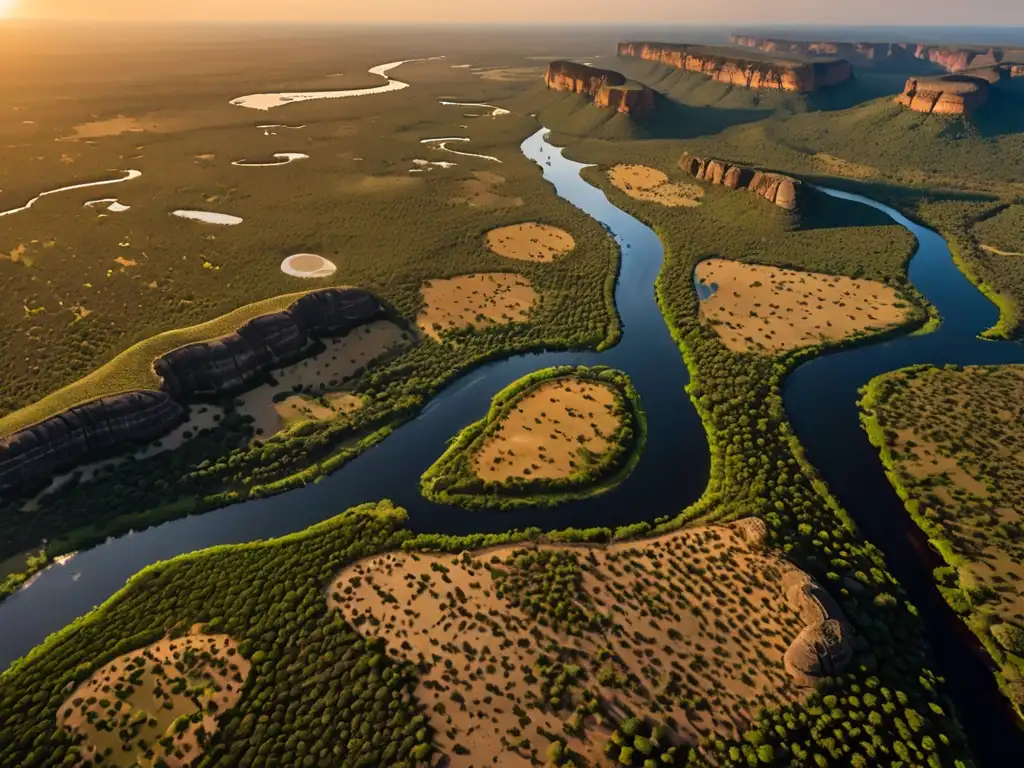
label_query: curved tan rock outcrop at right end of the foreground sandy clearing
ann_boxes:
[782,567,853,686]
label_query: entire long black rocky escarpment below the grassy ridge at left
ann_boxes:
[0,288,387,488]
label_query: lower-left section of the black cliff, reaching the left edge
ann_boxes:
[0,391,185,487]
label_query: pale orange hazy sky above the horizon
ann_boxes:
[6,0,1024,26]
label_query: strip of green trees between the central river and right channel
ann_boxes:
[577,159,966,766]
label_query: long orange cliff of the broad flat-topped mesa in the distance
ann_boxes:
[618,42,853,93]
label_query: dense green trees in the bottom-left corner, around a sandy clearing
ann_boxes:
[0,503,431,768]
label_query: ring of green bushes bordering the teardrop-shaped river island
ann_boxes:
[420,366,646,509]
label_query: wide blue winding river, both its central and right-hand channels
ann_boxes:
[0,129,1024,765]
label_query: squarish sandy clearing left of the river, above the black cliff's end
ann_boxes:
[416,272,540,341]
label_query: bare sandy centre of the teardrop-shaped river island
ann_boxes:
[472,377,623,482]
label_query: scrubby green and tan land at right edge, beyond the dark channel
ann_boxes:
[860,366,1024,713]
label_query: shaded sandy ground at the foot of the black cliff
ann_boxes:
[238,321,411,437]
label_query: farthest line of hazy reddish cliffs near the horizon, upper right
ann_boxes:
[729,35,1024,72]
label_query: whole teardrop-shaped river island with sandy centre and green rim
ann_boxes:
[420,366,646,509]
